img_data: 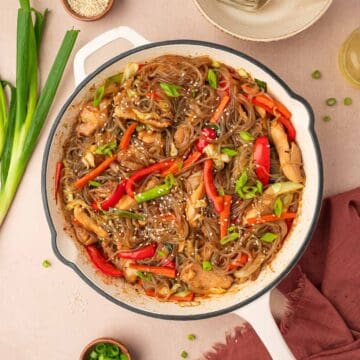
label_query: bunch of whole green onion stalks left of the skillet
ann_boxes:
[0,0,79,226]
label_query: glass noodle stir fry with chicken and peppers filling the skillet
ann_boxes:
[56,55,305,301]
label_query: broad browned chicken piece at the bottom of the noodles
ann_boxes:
[180,263,233,295]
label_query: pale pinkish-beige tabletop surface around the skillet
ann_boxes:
[0,0,360,360]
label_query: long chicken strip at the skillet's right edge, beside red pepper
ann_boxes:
[270,120,304,183]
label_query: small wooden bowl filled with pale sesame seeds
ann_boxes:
[61,0,114,21]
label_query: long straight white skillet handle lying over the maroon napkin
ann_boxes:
[234,291,295,360]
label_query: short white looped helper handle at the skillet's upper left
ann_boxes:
[74,26,149,85]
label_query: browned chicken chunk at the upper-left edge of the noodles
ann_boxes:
[76,98,111,136]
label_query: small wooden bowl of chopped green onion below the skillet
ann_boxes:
[80,338,131,360]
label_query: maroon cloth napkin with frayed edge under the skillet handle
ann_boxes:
[204,188,360,360]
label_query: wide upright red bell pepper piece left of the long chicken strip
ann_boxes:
[254,136,270,186]
